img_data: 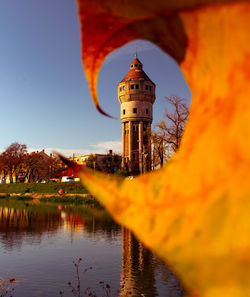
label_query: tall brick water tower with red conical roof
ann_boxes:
[118,55,155,175]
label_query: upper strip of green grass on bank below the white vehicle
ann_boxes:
[0,182,88,194]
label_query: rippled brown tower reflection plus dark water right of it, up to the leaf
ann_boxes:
[119,228,184,297]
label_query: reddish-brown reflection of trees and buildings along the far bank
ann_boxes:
[0,201,120,250]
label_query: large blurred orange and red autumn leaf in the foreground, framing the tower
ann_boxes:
[72,0,250,297]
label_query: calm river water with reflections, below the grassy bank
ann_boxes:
[0,199,184,297]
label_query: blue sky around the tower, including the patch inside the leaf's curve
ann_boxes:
[0,0,191,156]
